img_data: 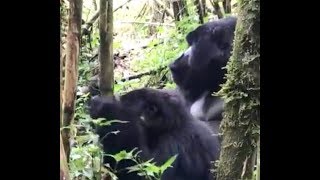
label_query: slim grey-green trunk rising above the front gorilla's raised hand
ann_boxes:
[99,0,114,95]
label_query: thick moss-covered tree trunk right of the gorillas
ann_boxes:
[217,0,260,180]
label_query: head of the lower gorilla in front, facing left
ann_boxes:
[120,88,188,132]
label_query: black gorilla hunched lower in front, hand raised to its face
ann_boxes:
[90,88,220,180]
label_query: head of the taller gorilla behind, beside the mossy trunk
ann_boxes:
[169,17,236,101]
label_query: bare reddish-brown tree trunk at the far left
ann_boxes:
[62,0,82,162]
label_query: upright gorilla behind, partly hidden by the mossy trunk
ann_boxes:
[169,17,237,130]
